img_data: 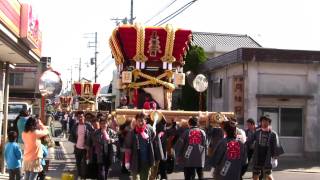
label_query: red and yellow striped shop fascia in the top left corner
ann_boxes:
[0,0,20,37]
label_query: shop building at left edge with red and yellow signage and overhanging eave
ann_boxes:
[0,0,41,136]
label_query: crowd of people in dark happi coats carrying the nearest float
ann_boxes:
[63,106,283,180]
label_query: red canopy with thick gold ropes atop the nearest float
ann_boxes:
[110,24,192,66]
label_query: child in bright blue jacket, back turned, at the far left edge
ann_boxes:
[4,131,22,180]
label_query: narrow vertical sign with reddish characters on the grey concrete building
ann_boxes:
[233,76,244,123]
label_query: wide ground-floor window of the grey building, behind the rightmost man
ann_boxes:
[258,107,303,137]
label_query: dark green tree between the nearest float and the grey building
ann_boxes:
[181,46,207,111]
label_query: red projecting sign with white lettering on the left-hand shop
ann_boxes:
[20,4,41,49]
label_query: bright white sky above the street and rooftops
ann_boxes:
[20,0,320,89]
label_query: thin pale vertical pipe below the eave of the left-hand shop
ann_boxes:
[1,62,10,174]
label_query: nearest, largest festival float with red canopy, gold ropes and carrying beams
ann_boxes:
[109,24,233,125]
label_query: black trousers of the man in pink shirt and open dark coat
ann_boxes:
[74,147,87,178]
